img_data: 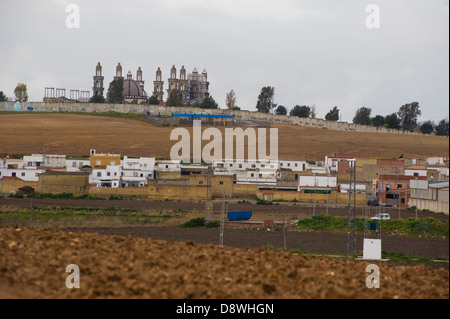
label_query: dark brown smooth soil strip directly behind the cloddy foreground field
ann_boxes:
[64,226,449,258]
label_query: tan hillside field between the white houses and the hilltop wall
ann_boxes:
[0,112,449,160]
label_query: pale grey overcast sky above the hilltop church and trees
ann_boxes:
[0,0,449,121]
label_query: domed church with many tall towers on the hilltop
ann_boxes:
[92,62,209,106]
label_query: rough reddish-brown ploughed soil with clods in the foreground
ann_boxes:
[0,227,449,299]
